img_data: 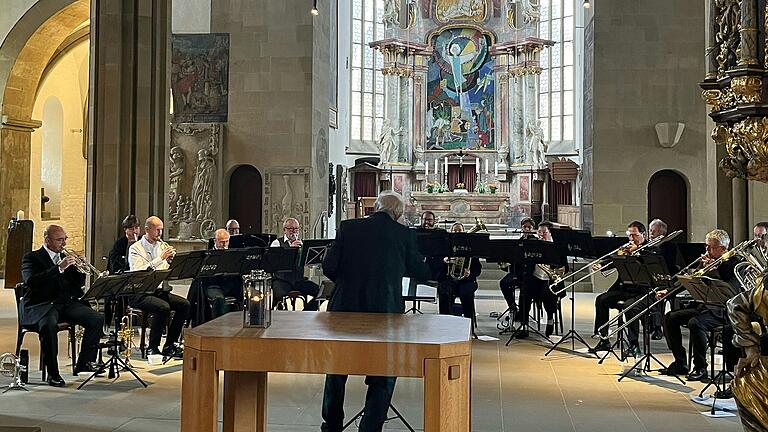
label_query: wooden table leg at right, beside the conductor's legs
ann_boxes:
[424,356,471,432]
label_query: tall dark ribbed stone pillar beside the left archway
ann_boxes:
[86,0,171,258]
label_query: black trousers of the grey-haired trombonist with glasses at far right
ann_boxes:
[664,304,730,370]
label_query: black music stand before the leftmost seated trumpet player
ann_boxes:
[77,270,169,390]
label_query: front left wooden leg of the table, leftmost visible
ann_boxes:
[181,347,219,432]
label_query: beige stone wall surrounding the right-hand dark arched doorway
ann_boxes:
[593,0,723,240]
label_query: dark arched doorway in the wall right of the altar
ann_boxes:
[648,169,690,238]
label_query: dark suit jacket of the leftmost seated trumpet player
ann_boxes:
[19,247,85,325]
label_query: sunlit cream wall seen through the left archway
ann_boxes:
[28,40,89,252]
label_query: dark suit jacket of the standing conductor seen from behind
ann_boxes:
[323,212,429,313]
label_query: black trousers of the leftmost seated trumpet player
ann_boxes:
[37,302,104,377]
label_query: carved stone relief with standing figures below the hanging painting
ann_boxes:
[166,123,223,240]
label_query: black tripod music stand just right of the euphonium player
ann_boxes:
[498,239,562,346]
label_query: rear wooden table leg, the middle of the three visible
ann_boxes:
[224,371,267,432]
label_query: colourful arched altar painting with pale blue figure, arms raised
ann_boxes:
[426,28,494,150]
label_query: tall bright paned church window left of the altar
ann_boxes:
[350,0,384,141]
